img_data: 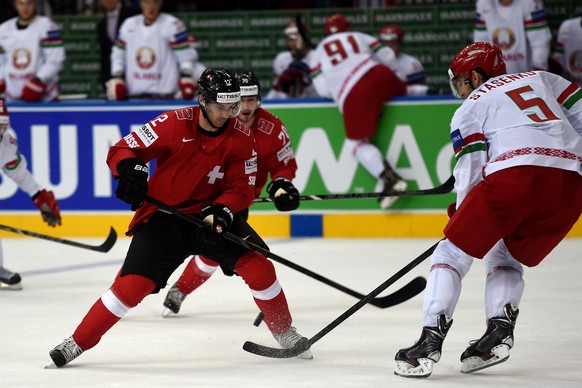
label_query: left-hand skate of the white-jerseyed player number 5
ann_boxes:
[394,315,453,377]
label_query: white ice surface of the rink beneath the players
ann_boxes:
[0,238,582,388]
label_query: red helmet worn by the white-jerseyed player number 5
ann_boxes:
[449,42,506,97]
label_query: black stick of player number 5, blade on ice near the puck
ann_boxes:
[243,240,442,358]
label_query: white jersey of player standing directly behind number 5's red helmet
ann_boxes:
[473,0,552,73]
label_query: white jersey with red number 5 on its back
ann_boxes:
[451,71,582,207]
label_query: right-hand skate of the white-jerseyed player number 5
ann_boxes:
[461,304,519,373]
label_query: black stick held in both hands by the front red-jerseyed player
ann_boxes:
[145,196,426,308]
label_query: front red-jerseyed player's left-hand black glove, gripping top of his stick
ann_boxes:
[115,158,148,211]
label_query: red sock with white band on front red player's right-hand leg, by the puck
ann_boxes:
[235,252,292,334]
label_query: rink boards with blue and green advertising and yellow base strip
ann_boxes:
[0,97,582,237]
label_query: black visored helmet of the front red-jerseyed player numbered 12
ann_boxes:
[198,68,241,116]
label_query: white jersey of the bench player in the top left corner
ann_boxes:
[0,16,65,101]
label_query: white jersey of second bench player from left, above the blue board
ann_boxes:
[111,13,198,97]
